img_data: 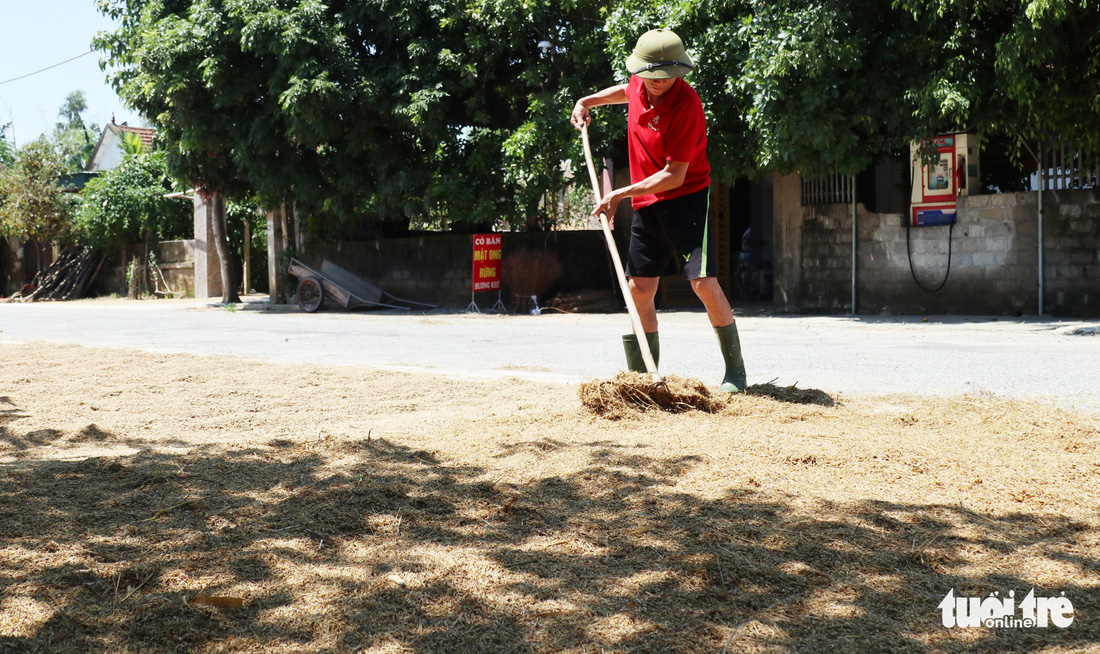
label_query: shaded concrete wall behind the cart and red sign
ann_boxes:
[301,230,620,309]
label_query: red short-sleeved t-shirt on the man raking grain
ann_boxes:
[626,76,711,209]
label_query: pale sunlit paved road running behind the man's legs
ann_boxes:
[0,298,1100,410]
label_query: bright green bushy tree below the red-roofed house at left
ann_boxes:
[75,153,195,248]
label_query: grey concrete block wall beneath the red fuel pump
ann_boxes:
[776,190,1100,317]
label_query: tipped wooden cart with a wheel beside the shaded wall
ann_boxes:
[289,258,437,313]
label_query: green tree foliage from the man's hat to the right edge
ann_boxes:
[607,0,1100,179]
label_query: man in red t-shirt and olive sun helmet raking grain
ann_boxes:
[571,30,746,392]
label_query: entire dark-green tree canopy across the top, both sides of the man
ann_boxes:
[96,0,1100,230]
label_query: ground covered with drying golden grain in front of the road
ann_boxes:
[0,343,1100,654]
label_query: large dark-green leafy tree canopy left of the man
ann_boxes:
[96,0,606,232]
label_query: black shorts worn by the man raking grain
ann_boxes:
[626,187,717,279]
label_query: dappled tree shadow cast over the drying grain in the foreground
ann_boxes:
[0,419,1100,654]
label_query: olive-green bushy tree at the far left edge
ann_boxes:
[0,138,78,245]
